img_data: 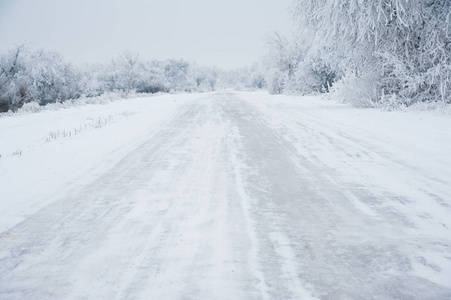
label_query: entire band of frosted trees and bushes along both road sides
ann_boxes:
[0,0,451,112]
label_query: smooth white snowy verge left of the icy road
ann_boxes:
[0,94,200,232]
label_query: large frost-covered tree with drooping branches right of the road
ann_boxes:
[293,0,451,105]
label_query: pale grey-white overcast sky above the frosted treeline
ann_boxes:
[0,0,291,69]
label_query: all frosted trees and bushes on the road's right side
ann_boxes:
[267,0,451,108]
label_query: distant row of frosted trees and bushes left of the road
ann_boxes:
[0,46,264,112]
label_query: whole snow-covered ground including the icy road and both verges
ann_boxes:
[0,92,451,299]
